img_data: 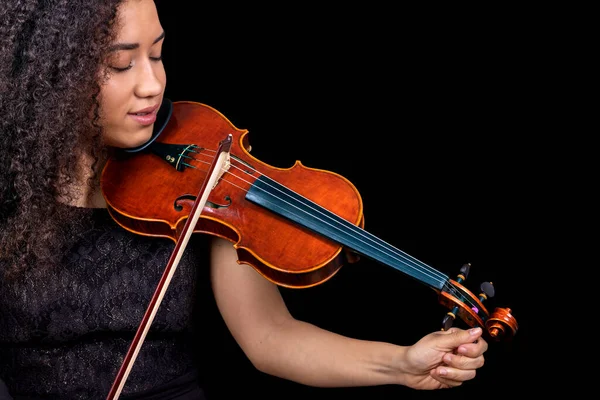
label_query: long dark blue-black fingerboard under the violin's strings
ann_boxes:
[246,176,449,290]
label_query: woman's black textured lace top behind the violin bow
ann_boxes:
[0,207,208,399]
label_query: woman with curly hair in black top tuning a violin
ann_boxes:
[0,0,488,399]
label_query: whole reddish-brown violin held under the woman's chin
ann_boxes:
[101,99,518,397]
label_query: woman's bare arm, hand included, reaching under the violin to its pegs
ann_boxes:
[211,239,487,388]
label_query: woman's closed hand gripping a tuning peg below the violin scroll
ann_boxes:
[403,328,488,389]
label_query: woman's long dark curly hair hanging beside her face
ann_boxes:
[0,0,123,278]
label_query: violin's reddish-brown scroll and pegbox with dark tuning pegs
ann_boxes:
[439,264,518,341]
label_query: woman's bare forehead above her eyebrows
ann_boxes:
[117,0,162,42]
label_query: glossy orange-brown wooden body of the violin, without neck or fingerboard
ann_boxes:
[101,101,364,288]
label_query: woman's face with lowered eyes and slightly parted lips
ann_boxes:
[100,0,167,148]
